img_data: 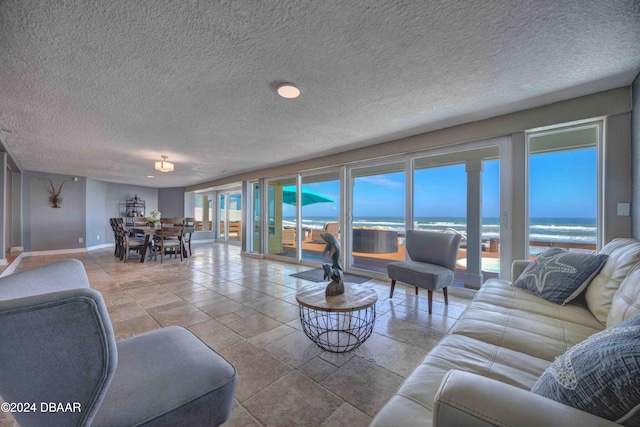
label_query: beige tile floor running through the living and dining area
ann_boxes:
[0,243,470,427]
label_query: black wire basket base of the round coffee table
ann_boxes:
[300,304,376,353]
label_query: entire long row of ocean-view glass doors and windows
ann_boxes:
[247,123,602,287]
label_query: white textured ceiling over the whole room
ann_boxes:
[0,0,640,187]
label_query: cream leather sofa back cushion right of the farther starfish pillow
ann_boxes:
[585,239,640,325]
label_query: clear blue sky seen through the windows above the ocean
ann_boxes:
[284,148,597,218]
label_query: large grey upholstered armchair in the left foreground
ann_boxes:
[0,260,237,427]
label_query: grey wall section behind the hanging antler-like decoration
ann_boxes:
[22,171,87,252]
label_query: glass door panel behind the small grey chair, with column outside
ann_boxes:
[412,146,500,287]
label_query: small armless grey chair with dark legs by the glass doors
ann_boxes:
[387,230,461,314]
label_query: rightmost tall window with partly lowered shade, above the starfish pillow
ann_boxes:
[528,125,598,256]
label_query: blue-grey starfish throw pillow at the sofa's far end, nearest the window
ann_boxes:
[513,248,607,305]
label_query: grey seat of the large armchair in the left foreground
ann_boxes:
[92,326,238,426]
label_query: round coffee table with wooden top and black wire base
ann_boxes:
[296,282,378,353]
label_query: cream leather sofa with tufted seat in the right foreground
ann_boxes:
[371,239,640,427]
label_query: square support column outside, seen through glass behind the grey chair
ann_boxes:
[464,159,483,288]
